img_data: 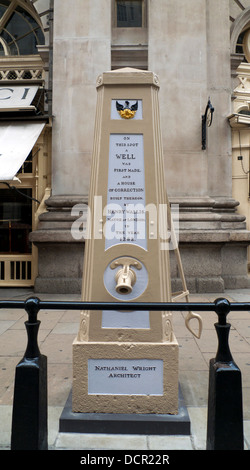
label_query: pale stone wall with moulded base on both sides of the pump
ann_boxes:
[31,0,250,292]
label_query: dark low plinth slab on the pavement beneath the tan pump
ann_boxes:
[59,386,191,435]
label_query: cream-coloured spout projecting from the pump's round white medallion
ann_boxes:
[110,257,142,295]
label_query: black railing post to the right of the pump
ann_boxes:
[207,299,244,450]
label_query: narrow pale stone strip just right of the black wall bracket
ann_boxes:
[206,0,232,198]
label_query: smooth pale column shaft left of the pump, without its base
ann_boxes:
[52,0,111,195]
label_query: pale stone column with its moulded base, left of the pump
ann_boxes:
[31,0,111,293]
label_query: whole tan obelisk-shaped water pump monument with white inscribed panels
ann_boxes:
[69,68,202,432]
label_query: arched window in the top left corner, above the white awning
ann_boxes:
[0,0,44,56]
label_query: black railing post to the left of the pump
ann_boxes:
[11,298,48,450]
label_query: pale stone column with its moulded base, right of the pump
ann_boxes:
[148,0,250,292]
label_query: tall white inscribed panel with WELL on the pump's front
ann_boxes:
[105,134,147,250]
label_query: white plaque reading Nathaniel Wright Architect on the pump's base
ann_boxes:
[88,359,163,395]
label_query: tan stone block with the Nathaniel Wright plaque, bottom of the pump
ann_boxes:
[72,335,179,414]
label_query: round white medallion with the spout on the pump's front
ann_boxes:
[104,256,148,301]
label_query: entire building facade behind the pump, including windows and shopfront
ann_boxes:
[0,0,250,293]
